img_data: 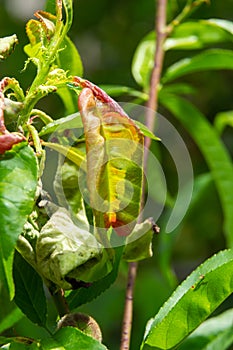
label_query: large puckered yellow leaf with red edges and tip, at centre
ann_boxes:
[79,81,143,235]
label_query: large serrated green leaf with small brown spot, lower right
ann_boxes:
[141,250,233,349]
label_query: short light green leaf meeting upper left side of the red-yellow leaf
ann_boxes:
[39,113,83,136]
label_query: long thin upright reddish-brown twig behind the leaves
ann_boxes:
[120,0,167,350]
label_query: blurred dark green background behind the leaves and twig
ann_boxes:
[0,0,233,350]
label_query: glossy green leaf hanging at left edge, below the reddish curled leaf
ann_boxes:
[0,142,37,297]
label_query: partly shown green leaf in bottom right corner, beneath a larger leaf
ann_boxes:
[179,309,233,350]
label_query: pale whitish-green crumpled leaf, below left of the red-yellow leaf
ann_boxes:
[36,208,112,289]
